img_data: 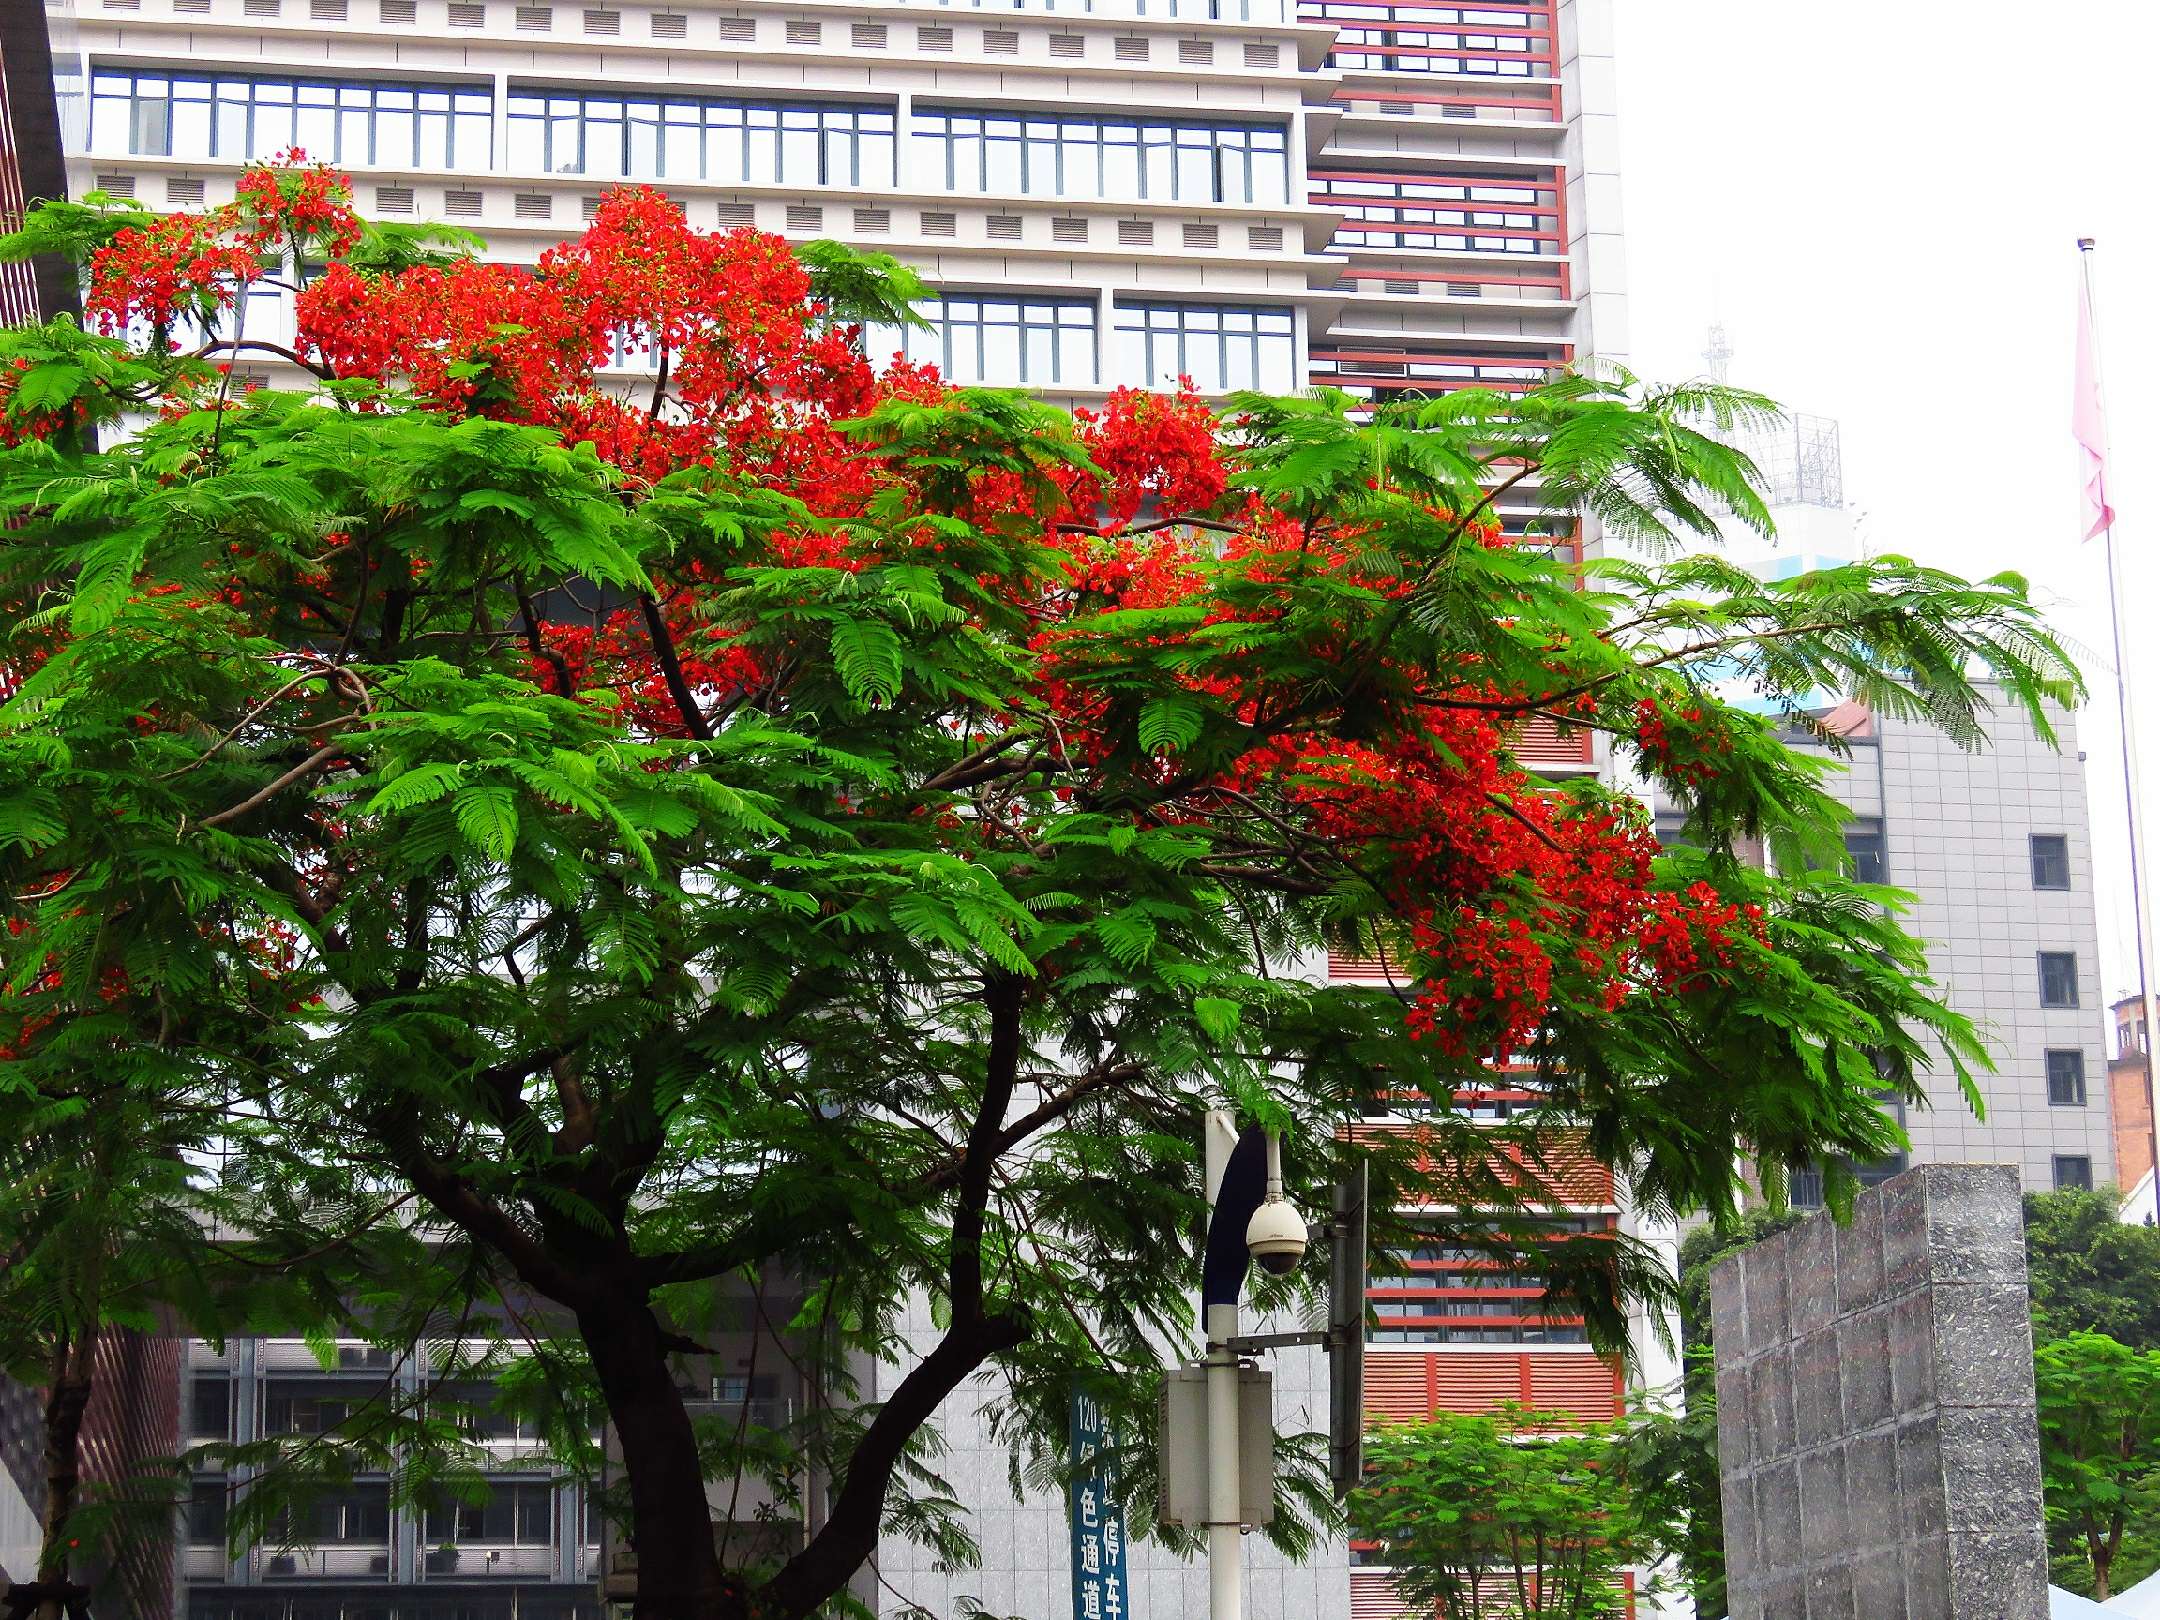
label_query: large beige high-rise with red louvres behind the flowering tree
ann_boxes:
[33,0,1648,1620]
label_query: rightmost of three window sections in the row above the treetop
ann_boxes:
[914,108,1290,203]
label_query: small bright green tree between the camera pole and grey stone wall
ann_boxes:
[1350,1406,1674,1620]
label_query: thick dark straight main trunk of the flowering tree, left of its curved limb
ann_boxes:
[577,1292,747,1620]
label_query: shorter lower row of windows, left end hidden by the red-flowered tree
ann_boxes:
[868,294,1296,393]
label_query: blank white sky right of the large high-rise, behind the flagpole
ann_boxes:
[1616,0,2160,996]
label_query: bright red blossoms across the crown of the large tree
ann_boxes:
[67,153,1763,1061]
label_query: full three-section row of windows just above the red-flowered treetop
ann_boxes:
[91,69,1290,205]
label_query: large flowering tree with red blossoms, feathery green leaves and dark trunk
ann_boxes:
[0,162,2076,1620]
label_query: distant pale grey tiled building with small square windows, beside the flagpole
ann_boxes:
[1684,403,2108,1207]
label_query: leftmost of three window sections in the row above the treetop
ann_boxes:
[91,69,495,173]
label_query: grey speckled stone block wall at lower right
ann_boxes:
[1711,1164,2048,1620]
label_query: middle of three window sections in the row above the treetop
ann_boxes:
[508,93,894,186]
